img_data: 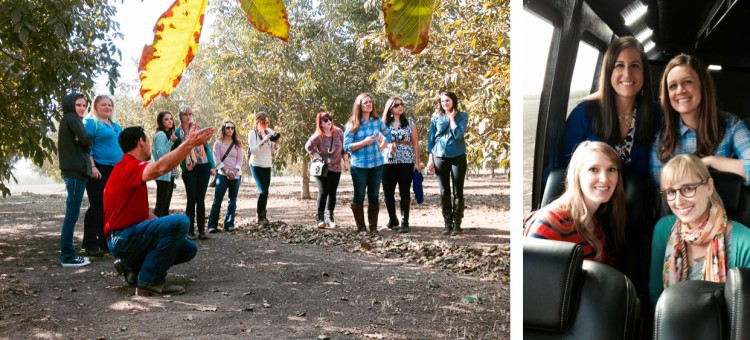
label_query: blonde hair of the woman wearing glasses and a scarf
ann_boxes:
[659,154,724,207]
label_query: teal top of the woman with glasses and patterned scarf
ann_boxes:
[648,215,750,307]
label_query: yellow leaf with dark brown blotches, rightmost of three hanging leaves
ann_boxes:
[383,0,435,54]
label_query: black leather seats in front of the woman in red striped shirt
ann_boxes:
[523,238,640,340]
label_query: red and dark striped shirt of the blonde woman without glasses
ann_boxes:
[524,209,614,265]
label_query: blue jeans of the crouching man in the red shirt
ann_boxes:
[109,215,198,286]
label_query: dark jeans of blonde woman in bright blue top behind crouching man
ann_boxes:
[83,163,114,251]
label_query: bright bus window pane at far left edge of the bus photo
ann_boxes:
[521,9,554,215]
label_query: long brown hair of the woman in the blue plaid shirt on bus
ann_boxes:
[656,54,726,163]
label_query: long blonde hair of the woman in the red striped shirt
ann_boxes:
[550,141,625,259]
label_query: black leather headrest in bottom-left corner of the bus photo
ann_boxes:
[523,237,583,332]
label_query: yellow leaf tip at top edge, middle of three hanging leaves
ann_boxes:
[237,0,289,41]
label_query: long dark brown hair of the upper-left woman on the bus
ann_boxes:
[583,37,659,145]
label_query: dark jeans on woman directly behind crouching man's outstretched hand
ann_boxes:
[182,163,211,234]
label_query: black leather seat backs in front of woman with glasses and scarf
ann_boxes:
[653,268,750,340]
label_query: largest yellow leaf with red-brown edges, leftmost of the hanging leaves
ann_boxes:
[138,0,208,107]
